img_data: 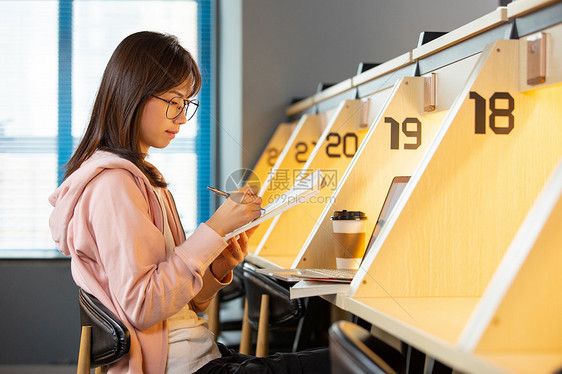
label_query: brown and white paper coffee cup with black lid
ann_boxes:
[332,210,367,269]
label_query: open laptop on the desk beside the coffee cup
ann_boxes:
[257,176,410,283]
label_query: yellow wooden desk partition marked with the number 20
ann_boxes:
[256,98,376,263]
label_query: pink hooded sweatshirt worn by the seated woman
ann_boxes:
[49,151,228,373]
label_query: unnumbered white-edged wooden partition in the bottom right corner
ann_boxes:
[466,160,562,373]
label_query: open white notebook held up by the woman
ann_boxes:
[223,170,326,240]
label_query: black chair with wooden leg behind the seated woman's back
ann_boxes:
[77,289,130,374]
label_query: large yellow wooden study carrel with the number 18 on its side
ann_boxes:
[246,1,562,373]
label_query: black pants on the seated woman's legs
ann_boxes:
[195,343,330,374]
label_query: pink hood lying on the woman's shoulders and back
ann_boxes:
[49,151,152,256]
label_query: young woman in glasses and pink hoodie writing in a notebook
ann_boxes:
[49,32,329,373]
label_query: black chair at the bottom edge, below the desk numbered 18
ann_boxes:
[329,321,406,374]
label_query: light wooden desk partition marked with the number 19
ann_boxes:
[297,77,446,268]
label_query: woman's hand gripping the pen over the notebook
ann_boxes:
[206,186,262,236]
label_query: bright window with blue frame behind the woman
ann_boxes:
[0,0,213,257]
